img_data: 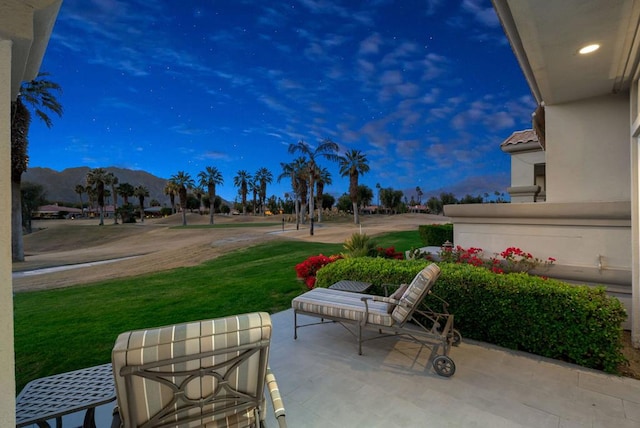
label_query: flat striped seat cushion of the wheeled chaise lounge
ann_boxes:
[291,288,393,326]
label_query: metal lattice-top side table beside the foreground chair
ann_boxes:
[16,363,116,428]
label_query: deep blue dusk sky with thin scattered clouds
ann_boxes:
[29,0,535,204]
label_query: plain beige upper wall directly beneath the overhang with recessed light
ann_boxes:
[545,93,631,203]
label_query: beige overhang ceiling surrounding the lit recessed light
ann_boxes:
[492,0,640,105]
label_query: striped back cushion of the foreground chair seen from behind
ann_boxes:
[112,312,271,428]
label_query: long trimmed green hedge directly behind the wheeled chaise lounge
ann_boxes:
[317,257,626,373]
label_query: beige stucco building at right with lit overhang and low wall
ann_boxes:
[444,0,640,347]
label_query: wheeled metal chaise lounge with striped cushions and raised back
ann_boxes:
[291,264,462,377]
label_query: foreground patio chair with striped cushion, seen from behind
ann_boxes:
[112,312,286,428]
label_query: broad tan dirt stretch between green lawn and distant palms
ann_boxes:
[13,214,443,292]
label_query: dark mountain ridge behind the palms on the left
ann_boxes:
[22,166,172,206]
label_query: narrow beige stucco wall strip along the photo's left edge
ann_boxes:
[0,39,16,427]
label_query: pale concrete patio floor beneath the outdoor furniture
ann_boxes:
[32,310,640,428]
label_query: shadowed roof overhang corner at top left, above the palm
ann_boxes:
[0,0,62,100]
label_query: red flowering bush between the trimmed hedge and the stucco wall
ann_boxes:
[436,245,556,273]
